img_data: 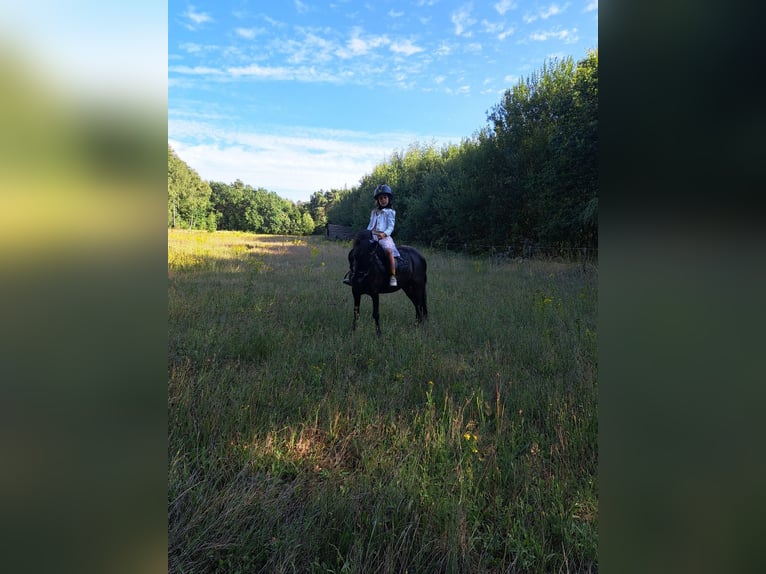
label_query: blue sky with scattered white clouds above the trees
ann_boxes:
[168,0,598,201]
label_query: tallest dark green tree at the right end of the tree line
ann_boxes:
[487,52,598,250]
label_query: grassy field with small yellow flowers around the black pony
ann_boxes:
[168,230,598,574]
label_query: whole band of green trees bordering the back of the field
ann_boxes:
[168,50,598,250]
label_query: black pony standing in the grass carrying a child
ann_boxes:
[348,230,428,335]
